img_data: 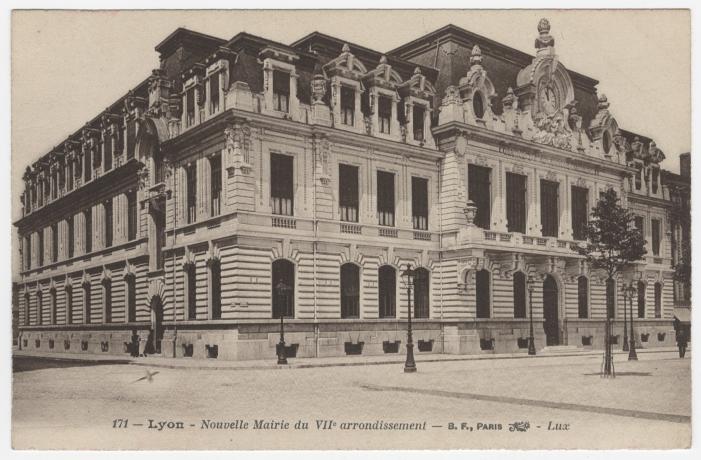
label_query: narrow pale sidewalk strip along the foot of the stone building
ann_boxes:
[12,347,690,370]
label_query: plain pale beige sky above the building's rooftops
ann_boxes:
[12,10,691,225]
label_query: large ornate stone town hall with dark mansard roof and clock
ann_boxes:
[16,20,688,360]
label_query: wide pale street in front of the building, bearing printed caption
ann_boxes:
[12,352,691,449]
